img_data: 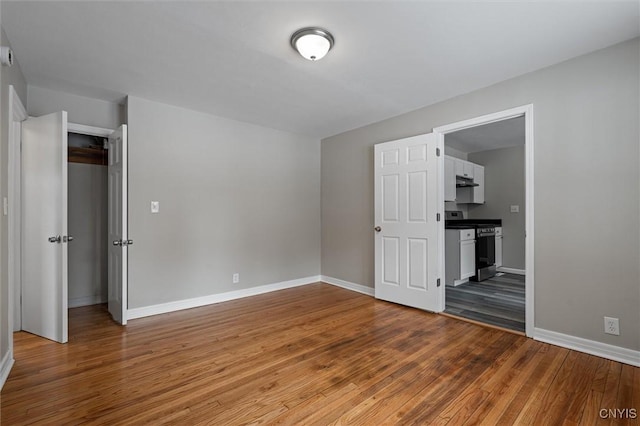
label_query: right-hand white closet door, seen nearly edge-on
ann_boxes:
[108,124,132,325]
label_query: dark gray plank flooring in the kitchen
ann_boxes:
[444,273,525,332]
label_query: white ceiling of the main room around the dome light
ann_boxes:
[1,0,640,137]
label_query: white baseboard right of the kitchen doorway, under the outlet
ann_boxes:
[533,328,640,367]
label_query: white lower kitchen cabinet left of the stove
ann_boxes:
[445,229,476,287]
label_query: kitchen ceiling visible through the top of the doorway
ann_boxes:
[444,116,525,154]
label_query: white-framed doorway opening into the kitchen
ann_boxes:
[434,105,534,336]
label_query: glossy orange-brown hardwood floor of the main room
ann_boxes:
[1,284,640,426]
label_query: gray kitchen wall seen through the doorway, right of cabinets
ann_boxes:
[468,145,526,269]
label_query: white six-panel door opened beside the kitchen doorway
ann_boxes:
[374,133,444,312]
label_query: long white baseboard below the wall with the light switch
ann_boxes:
[127,275,320,320]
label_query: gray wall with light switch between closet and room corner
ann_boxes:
[127,97,320,308]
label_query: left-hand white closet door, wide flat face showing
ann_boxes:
[22,111,68,343]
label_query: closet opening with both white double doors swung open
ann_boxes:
[14,115,132,343]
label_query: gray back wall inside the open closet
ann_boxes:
[68,163,108,308]
